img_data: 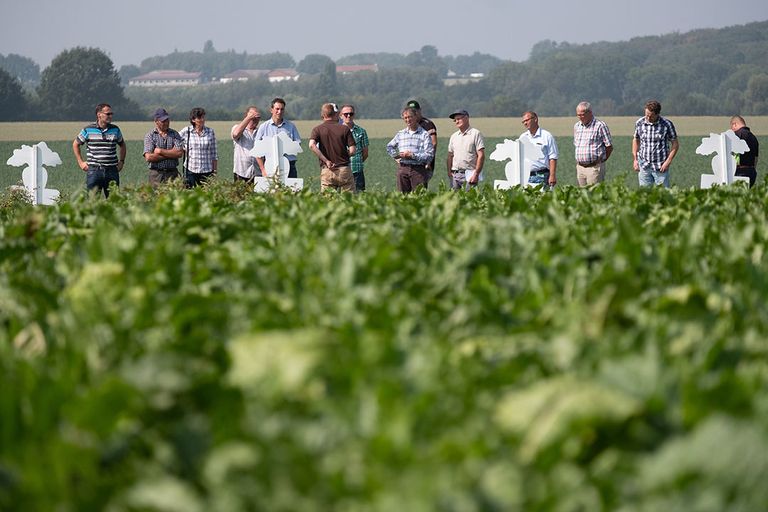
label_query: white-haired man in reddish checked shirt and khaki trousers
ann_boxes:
[573,101,613,187]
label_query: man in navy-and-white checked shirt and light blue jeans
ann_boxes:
[632,100,680,188]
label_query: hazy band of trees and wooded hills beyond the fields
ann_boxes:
[0,21,768,120]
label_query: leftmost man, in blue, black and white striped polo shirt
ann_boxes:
[72,103,126,197]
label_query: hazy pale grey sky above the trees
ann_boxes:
[0,0,768,70]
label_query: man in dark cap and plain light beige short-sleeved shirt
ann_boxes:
[446,110,485,190]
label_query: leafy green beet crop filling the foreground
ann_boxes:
[0,185,768,512]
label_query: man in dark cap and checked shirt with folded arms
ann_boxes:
[144,108,184,187]
